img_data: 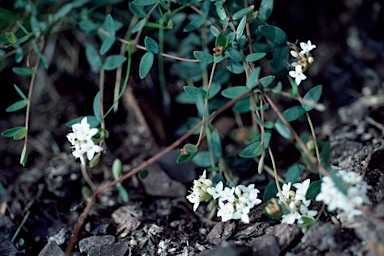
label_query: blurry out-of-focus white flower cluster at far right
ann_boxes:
[316,170,371,221]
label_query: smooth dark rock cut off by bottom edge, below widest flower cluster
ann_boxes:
[199,242,253,256]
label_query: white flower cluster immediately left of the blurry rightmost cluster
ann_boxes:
[276,179,317,224]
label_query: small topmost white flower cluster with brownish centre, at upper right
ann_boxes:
[289,40,316,85]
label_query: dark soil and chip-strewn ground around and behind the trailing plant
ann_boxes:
[0,0,384,256]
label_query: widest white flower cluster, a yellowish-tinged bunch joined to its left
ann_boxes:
[187,171,261,223]
